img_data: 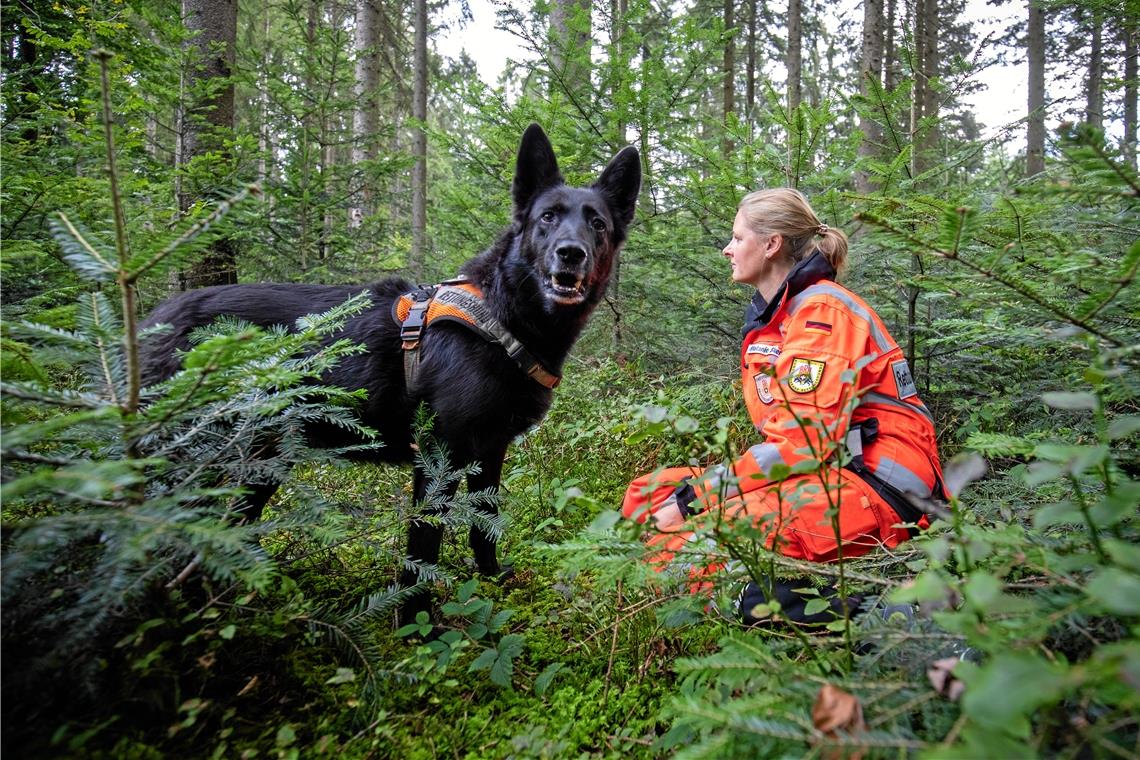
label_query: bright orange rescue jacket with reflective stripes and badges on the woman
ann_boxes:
[693,251,943,515]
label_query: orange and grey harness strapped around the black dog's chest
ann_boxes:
[392,277,562,390]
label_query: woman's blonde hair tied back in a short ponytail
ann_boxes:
[740,187,847,272]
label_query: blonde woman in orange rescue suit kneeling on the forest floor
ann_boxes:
[622,188,943,623]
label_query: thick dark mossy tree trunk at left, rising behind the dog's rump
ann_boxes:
[178,0,237,288]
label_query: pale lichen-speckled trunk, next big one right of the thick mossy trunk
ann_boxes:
[349,0,380,229]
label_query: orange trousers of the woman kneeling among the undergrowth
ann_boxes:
[621,467,925,578]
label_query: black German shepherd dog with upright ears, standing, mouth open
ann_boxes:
[143,124,641,621]
